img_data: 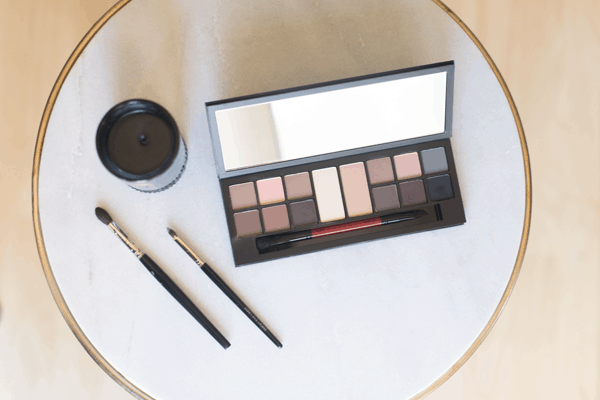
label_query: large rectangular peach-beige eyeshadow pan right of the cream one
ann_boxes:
[340,162,373,217]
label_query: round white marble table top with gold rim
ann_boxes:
[33,0,531,400]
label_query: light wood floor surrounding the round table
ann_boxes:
[0,0,600,400]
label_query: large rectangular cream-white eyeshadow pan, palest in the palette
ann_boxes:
[312,167,346,222]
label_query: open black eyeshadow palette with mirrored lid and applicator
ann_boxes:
[207,62,465,266]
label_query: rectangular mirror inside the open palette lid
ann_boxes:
[215,72,446,171]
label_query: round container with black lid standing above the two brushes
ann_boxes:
[96,99,187,192]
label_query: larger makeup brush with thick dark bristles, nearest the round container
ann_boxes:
[96,207,231,349]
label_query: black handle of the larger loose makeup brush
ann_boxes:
[140,254,231,349]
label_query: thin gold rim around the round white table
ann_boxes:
[32,0,532,400]
